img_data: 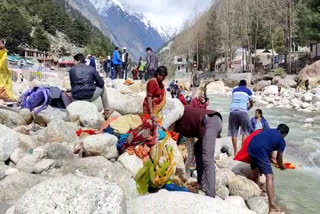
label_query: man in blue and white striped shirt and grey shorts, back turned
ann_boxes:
[228,80,253,154]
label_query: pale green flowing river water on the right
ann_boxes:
[209,95,320,214]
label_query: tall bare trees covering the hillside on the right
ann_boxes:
[173,0,320,73]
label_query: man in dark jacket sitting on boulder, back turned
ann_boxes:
[69,54,113,119]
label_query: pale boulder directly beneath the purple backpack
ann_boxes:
[34,106,67,126]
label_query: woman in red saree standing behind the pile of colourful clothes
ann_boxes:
[143,66,168,120]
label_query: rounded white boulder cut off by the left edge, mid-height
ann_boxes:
[0,124,19,161]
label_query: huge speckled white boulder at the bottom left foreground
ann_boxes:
[15,176,126,214]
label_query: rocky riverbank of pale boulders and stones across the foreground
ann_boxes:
[0,77,268,214]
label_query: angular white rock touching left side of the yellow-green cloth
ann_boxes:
[118,152,143,178]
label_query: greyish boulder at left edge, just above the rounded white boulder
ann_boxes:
[0,109,27,128]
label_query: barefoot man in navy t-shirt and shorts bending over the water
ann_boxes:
[248,124,289,212]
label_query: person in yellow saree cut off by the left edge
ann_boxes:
[0,40,14,101]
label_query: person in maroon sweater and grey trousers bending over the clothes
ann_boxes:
[169,106,222,197]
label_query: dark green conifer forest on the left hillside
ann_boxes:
[0,0,113,56]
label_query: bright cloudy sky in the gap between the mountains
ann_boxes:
[118,0,212,33]
